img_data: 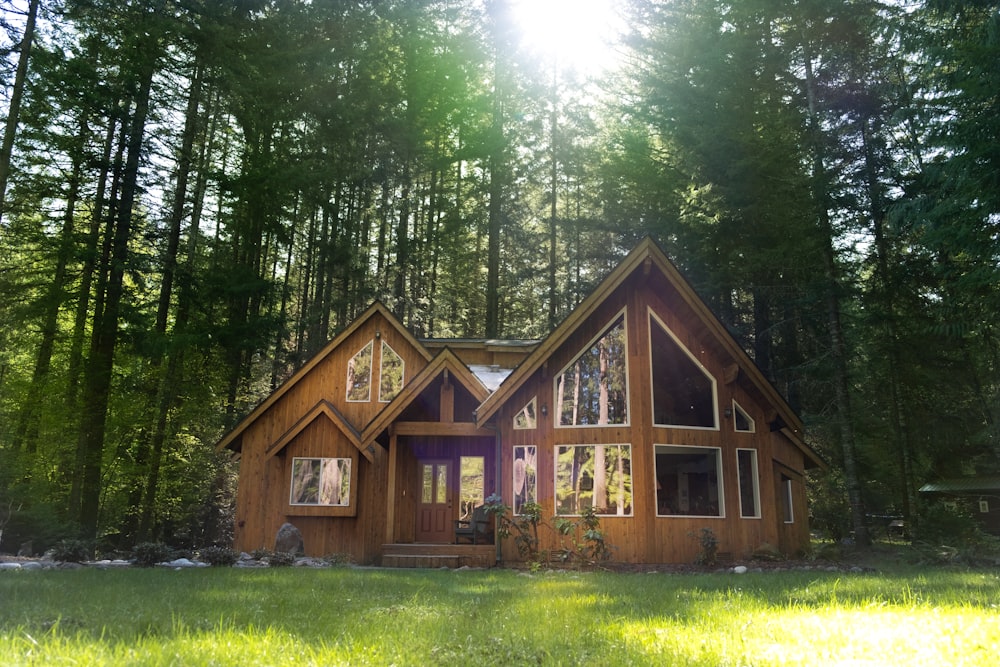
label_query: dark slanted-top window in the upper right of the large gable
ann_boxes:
[649,313,718,429]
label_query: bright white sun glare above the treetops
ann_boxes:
[511,0,623,75]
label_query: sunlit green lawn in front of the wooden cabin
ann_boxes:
[0,568,1000,667]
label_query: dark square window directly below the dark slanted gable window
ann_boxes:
[656,445,725,517]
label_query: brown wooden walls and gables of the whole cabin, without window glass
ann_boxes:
[220,244,822,564]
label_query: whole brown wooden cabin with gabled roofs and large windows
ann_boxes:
[218,240,824,566]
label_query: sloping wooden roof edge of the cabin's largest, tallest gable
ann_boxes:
[476,237,826,467]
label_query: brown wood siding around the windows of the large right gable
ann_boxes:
[496,276,809,563]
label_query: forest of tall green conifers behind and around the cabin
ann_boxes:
[0,0,1000,551]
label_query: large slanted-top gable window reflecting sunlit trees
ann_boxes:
[555,311,628,426]
